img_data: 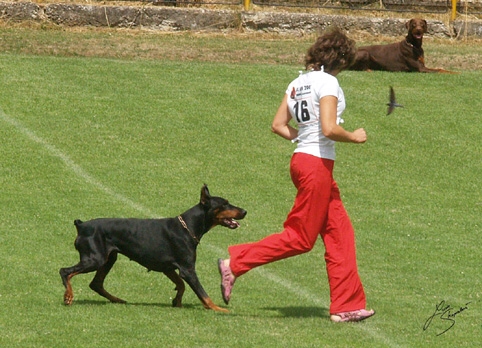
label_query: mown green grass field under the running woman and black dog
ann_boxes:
[0,27,482,348]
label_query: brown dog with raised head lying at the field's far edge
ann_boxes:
[349,18,453,73]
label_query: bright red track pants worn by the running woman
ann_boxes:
[228,153,366,314]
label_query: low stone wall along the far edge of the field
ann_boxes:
[0,2,482,37]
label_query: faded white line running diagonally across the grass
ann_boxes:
[0,108,399,347]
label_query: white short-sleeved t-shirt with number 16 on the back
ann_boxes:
[286,71,345,160]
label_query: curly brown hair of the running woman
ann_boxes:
[305,28,356,73]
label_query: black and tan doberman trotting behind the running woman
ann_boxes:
[60,185,246,312]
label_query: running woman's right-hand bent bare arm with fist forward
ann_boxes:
[320,96,367,143]
